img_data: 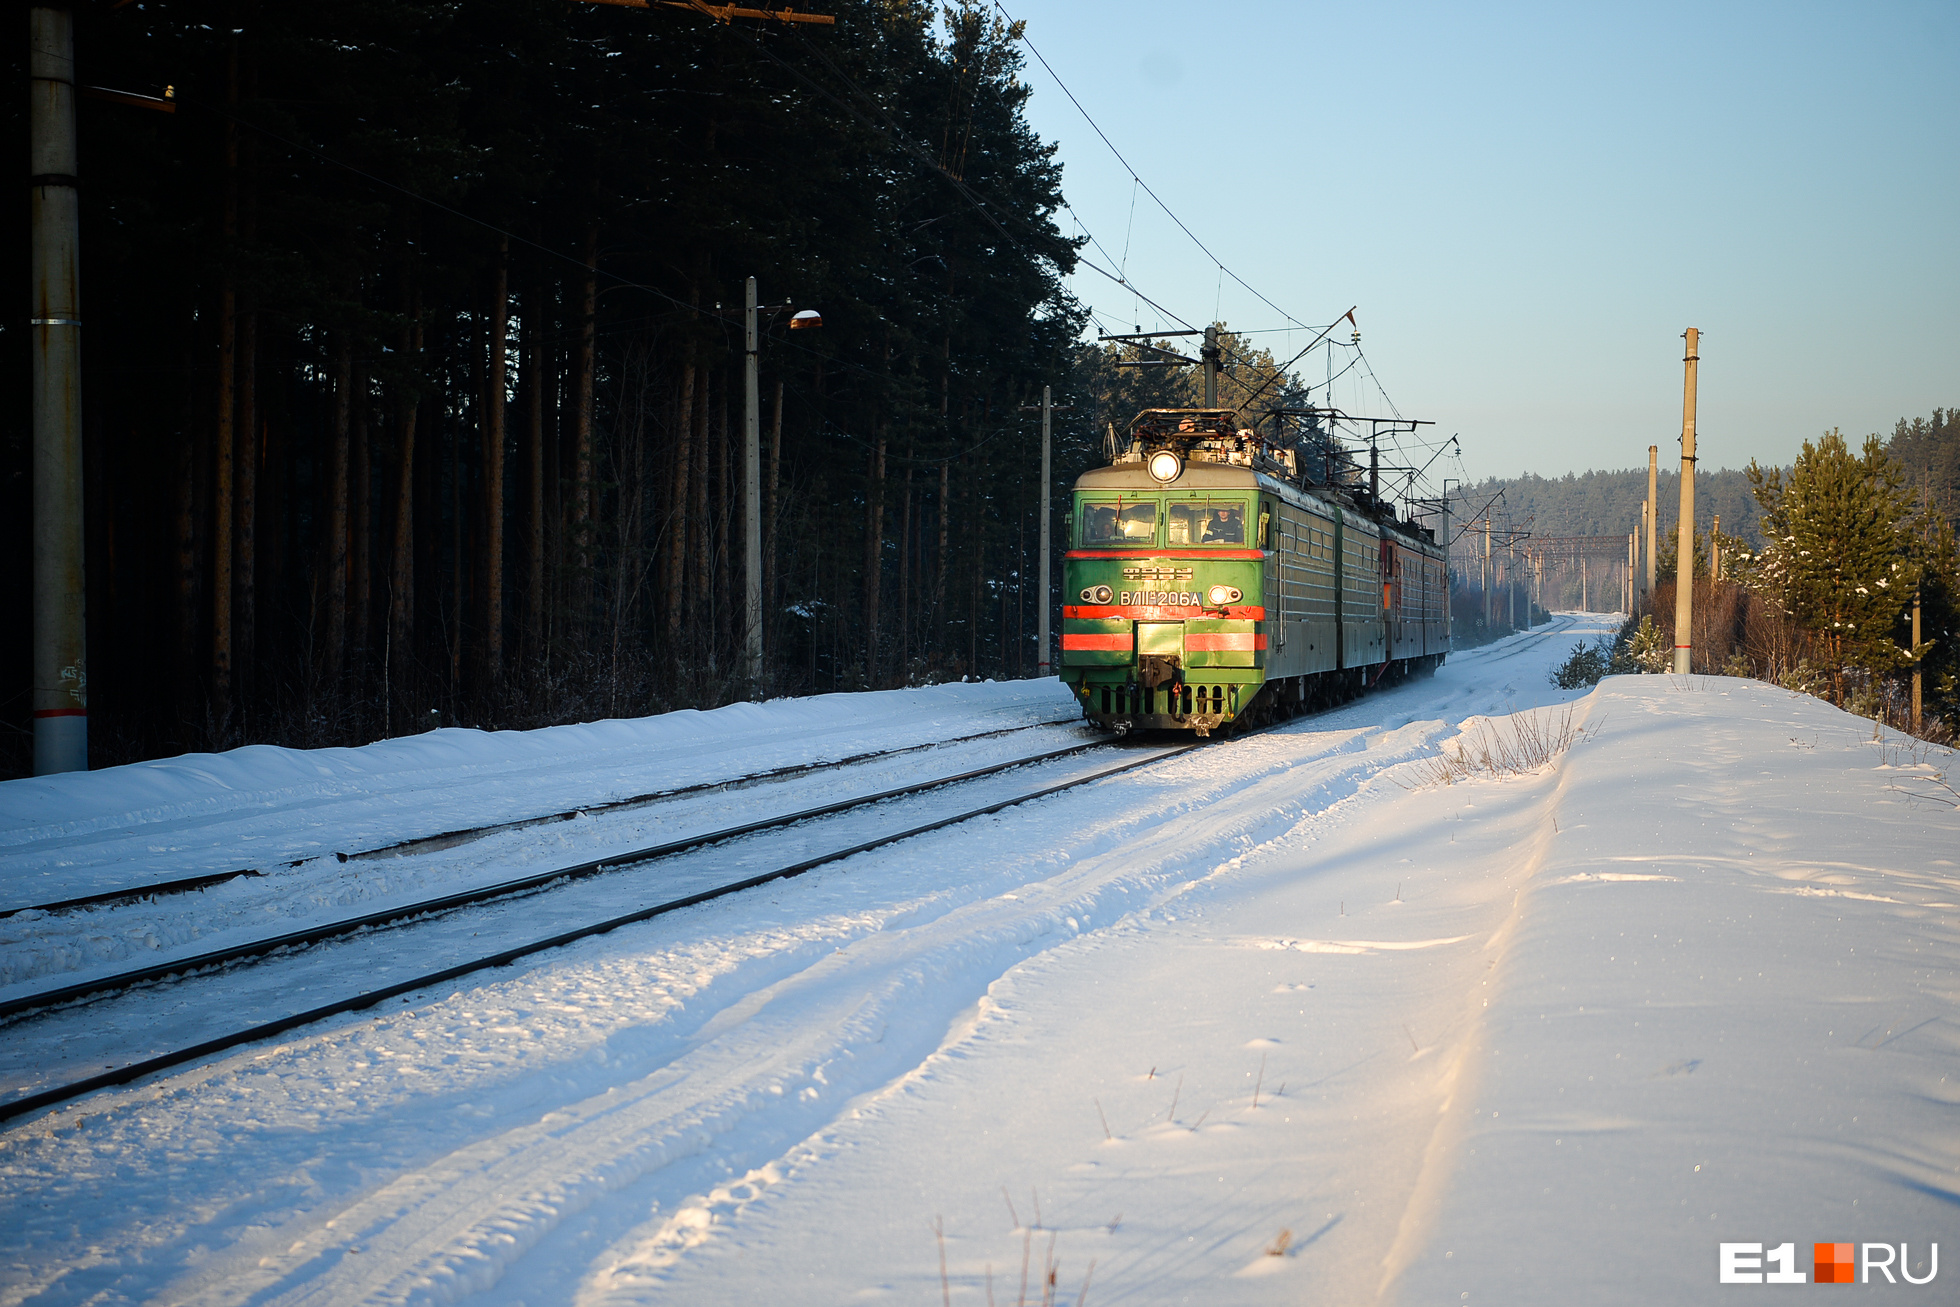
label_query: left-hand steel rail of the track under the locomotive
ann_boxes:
[0,739,1107,1021]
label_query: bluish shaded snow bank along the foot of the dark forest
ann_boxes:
[0,680,1078,903]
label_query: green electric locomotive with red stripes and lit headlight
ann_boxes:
[1062,410,1450,735]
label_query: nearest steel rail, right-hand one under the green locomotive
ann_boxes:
[0,741,1207,1121]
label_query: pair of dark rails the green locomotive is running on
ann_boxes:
[0,741,1203,1121]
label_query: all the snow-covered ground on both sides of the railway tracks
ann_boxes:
[0,617,1960,1305]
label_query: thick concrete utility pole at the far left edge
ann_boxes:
[27,4,88,776]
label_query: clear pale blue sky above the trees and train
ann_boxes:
[1004,0,1960,476]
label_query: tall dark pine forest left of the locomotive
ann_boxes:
[0,0,1096,774]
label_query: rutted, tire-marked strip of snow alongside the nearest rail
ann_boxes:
[10,630,1607,1301]
